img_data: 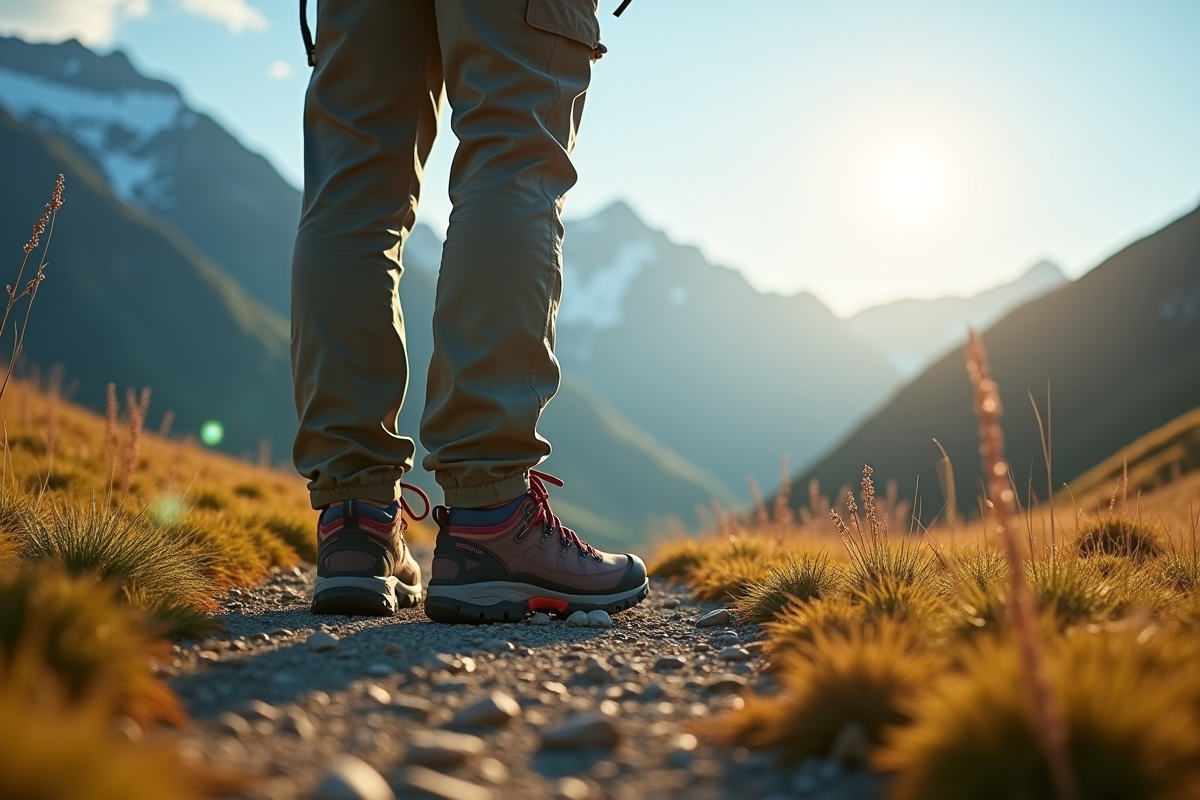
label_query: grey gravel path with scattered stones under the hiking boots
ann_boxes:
[160,547,881,800]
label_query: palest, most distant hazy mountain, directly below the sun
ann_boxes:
[850,261,1067,379]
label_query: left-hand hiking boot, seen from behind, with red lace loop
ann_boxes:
[312,483,430,616]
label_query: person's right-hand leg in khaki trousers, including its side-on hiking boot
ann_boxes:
[421,0,649,622]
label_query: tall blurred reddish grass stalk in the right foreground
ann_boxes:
[967,330,1079,800]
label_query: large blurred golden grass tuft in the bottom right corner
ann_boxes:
[876,632,1200,800]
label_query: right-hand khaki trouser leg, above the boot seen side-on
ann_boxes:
[421,0,599,506]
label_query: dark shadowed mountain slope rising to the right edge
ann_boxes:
[793,209,1200,522]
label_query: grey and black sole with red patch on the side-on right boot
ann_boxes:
[425,579,650,625]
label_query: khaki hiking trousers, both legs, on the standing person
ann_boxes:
[292,0,599,507]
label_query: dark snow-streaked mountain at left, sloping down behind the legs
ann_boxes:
[0,38,730,546]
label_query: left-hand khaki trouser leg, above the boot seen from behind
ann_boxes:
[292,0,443,507]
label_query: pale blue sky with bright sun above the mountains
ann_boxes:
[7,0,1200,314]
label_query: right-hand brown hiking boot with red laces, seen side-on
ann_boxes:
[425,470,650,624]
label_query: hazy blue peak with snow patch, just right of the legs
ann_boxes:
[540,203,900,498]
